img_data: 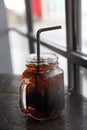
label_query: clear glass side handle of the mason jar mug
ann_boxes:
[20,78,30,110]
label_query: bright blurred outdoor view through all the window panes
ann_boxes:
[0,0,87,96]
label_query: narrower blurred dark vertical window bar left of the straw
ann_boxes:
[25,0,34,53]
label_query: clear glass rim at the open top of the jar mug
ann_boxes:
[26,52,58,65]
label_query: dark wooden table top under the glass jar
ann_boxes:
[0,74,87,130]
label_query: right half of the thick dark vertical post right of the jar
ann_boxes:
[73,0,81,92]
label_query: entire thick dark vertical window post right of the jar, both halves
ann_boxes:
[65,0,80,91]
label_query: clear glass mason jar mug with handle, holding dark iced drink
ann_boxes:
[20,53,64,120]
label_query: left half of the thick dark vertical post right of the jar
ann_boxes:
[65,0,75,91]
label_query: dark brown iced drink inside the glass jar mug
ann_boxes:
[21,65,64,119]
